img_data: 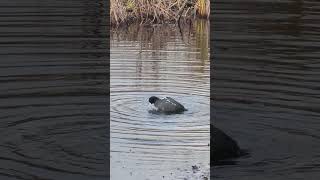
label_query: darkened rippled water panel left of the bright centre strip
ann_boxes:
[0,0,109,180]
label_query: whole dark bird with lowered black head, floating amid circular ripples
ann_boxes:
[149,96,187,114]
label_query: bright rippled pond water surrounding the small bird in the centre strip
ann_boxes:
[110,21,210,180]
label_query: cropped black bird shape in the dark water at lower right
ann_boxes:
[210,125,242,165]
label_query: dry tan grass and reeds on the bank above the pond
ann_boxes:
[110,0,210,24]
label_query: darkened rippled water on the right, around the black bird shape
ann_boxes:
[211,0,320,180]
